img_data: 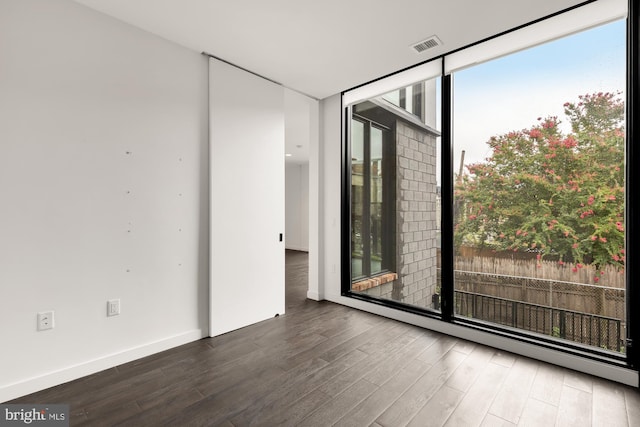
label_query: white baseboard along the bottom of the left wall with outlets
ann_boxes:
[0,329,206,403]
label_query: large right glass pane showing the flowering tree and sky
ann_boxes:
[453,21,626,353]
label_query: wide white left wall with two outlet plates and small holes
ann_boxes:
[0,0,208,402]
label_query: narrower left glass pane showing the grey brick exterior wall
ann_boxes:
[351,72,440,310]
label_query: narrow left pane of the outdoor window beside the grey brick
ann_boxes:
[351,120,364,277]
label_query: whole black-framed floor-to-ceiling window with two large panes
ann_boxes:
[343,2,630,374]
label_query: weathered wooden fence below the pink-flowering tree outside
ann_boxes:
[440,256,626,351]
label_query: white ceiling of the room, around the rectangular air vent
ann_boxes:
[76,0,583,99]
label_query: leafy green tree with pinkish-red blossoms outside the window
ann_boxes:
[455,93,625,268]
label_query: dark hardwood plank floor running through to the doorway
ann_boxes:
[12,251,640,427]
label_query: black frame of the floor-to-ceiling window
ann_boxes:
[341,0,640,371]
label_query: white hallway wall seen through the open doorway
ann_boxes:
[285,163,309,252]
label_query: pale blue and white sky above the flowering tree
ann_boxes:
[453,20,626,178]
